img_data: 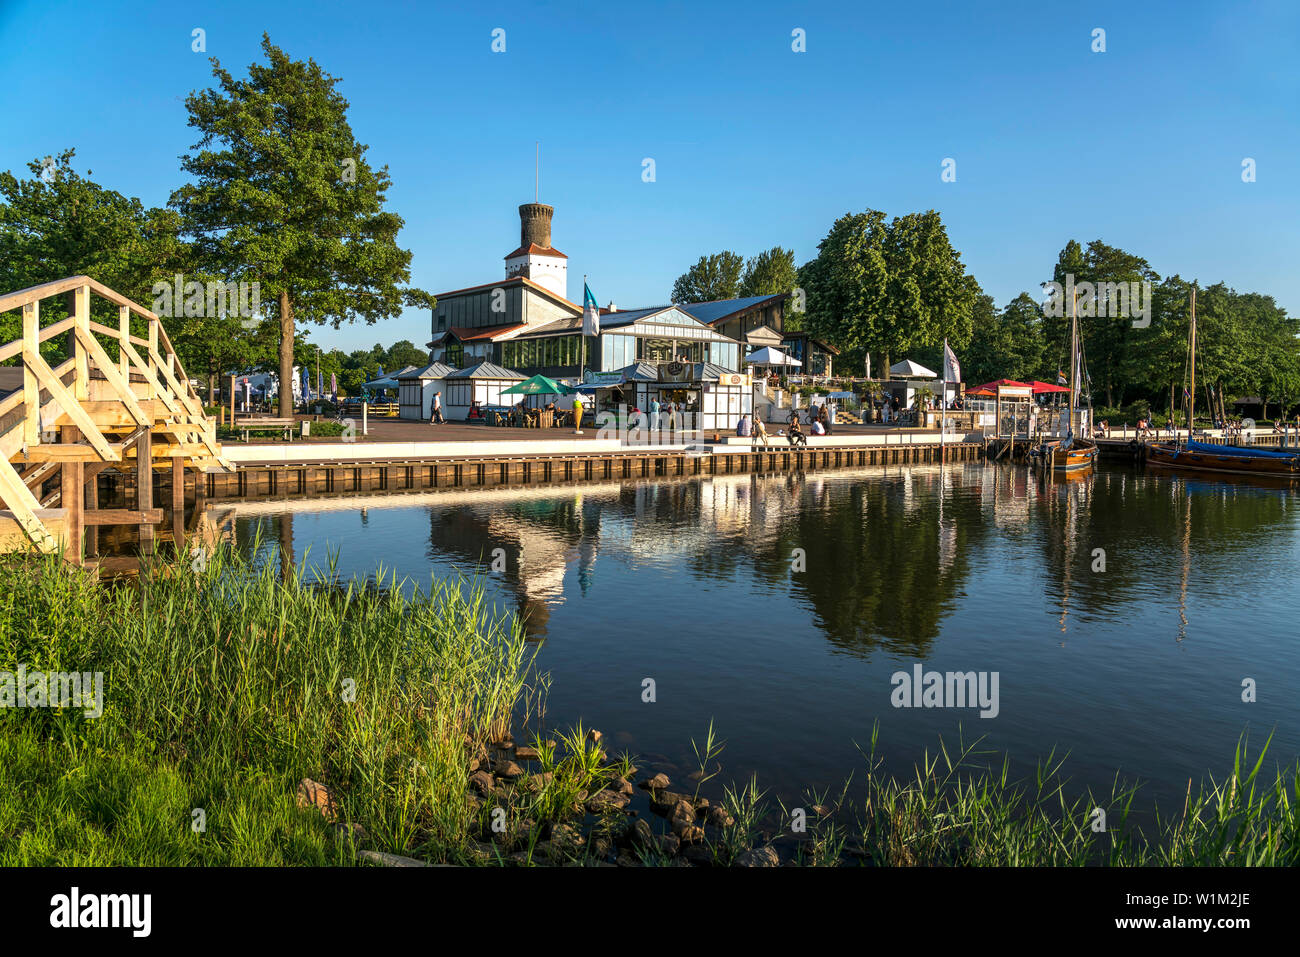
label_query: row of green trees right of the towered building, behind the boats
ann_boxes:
[672,217,1300,408]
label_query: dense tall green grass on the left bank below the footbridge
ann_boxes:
[0,547,529,863]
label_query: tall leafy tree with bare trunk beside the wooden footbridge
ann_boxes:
[170,34,433,416]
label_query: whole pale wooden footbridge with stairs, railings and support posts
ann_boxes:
[0,276,233,564]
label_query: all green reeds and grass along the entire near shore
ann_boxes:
[0,547,1300,866]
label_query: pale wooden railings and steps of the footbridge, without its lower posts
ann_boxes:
[0,276,231,550]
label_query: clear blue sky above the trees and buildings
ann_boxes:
[0,0,1300,348]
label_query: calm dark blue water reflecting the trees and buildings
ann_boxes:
[213,464,1300,805]
